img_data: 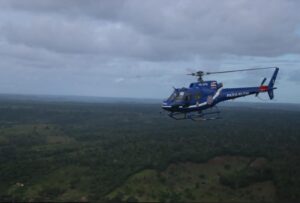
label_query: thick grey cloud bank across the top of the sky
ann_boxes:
[2,0,300,61]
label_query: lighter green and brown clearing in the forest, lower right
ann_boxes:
[107,156,278,202]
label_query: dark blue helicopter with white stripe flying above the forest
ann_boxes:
[161,67,279,121]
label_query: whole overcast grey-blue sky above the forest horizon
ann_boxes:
[0,0,300,103]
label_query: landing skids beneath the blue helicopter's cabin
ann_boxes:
[168,106,221,121]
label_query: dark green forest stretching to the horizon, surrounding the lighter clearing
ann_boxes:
[0,100,300,201]
